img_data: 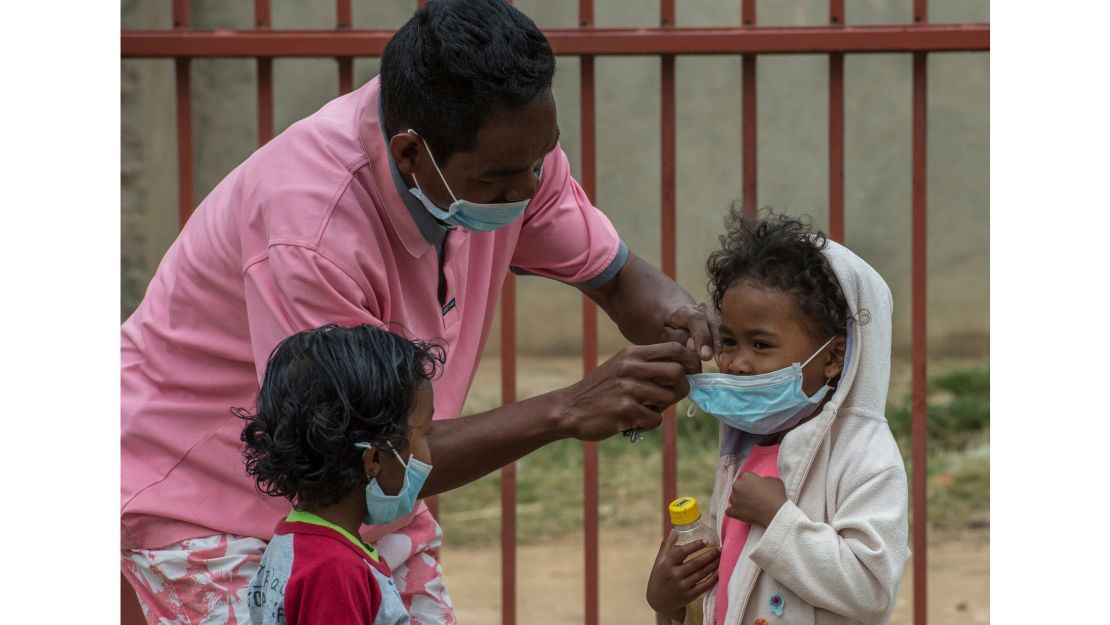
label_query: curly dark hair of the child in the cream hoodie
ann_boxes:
[705,204,849,340]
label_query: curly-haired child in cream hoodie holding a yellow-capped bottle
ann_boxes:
[647,210,909,625]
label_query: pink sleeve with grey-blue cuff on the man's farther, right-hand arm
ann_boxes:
[512,145,628,289]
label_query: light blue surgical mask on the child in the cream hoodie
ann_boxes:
[686,336,836,434]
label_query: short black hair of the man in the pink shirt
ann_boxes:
[381,0,555,165]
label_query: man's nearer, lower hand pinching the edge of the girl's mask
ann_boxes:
[558,343,702,441]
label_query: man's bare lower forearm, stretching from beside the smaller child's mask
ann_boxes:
[421,391,567,497]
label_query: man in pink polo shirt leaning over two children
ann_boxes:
[121,0,716,624]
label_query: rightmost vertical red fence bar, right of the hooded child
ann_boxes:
[910,0,928,625]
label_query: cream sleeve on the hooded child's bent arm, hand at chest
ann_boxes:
[750,465,909,624]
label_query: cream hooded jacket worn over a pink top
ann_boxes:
[674,242,909,625]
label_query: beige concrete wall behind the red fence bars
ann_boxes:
[121,0,989,356]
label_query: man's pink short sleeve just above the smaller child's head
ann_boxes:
[244,244,382,381]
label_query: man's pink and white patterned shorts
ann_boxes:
[121,510,456,625]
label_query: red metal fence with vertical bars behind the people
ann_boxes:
[121,0,990,625]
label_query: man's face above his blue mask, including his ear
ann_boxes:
[391,90,558,210]
